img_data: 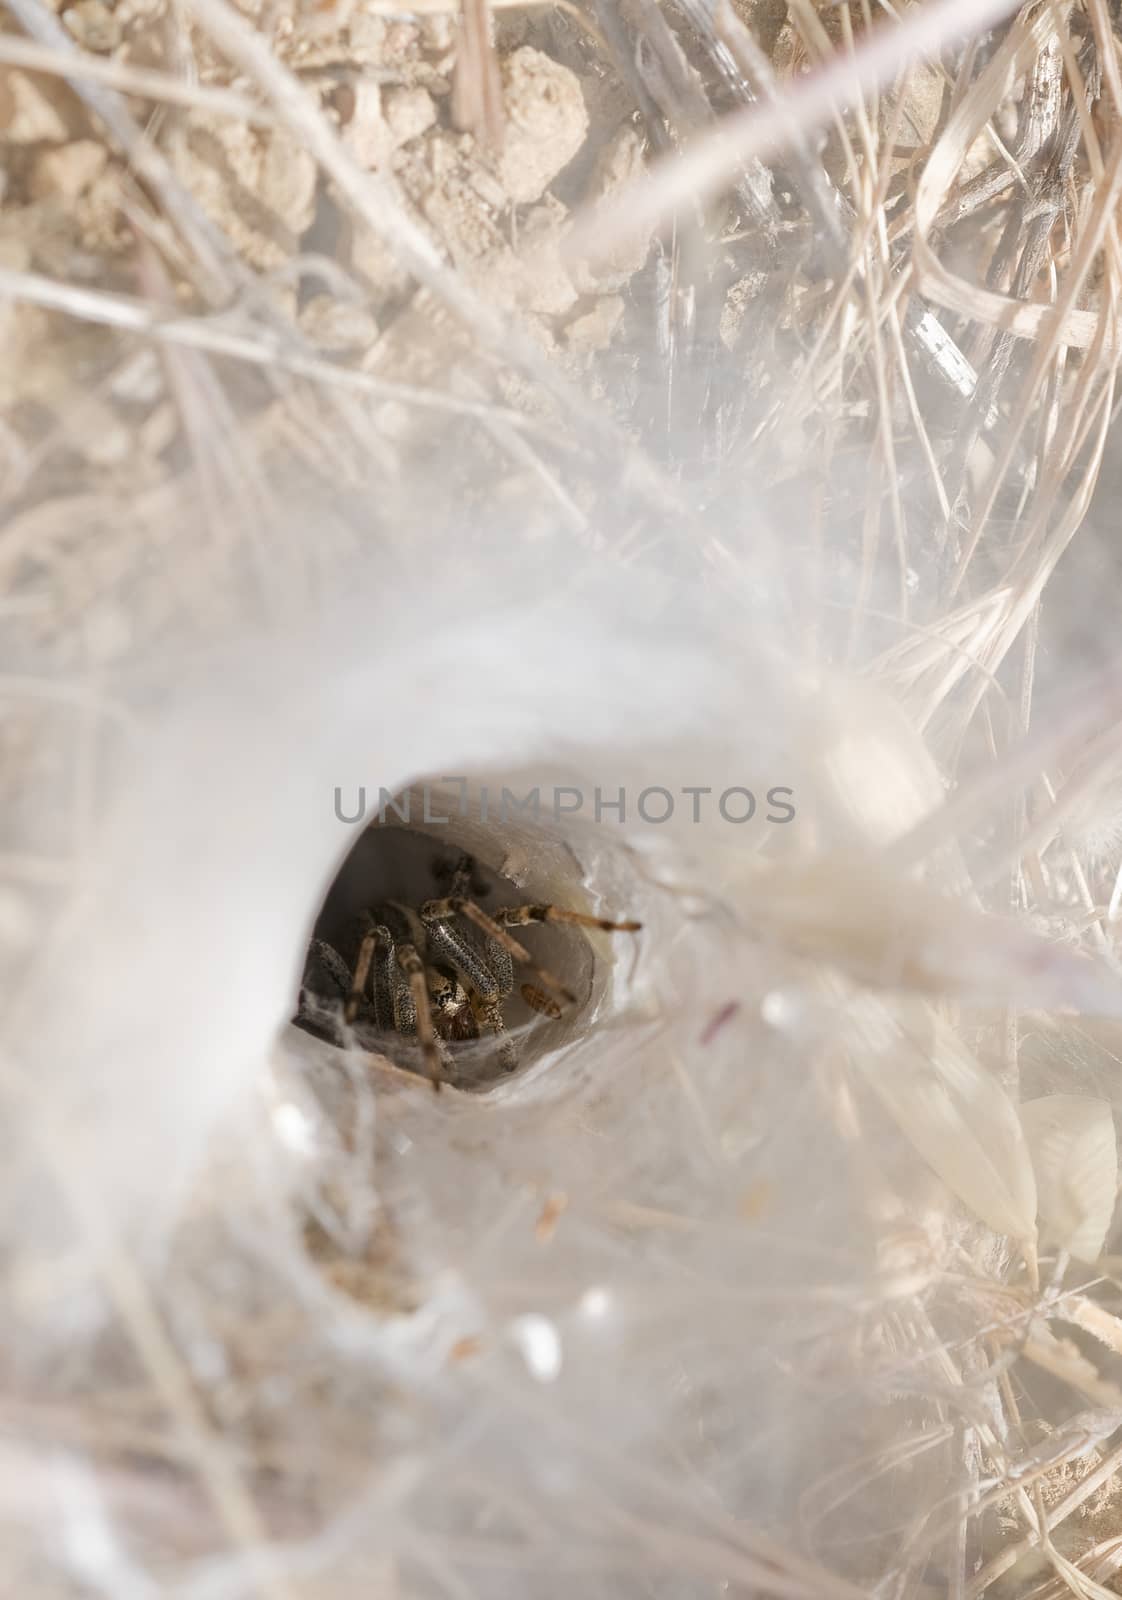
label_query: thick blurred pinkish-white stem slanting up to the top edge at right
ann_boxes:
[567,0,1016,261]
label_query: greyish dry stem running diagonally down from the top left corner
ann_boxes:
[3,0,240,301]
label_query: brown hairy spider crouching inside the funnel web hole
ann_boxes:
[298,856,642,1090]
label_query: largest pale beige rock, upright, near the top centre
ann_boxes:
[498,45,589,202]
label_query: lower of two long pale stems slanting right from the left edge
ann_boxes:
[0,267,546,435]
